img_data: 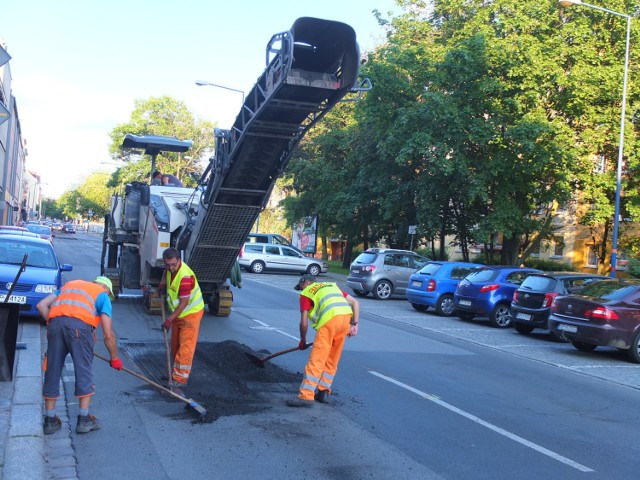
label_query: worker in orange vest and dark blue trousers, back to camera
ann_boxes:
[36,277,122,435]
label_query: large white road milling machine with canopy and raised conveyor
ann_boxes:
[102,17,371,316]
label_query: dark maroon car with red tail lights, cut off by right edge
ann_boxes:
[549,279,640,363]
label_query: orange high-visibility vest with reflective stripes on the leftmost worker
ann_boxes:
[49,280,104,327]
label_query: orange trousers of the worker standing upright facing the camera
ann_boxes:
[171,309,204,384]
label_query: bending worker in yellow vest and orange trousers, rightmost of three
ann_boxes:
[287,274,360,407]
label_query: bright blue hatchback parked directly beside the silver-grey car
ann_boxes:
[406,261,482,317]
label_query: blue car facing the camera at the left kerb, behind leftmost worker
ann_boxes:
[0,235,73,316]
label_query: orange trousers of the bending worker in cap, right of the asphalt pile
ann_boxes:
[298,314,351,400]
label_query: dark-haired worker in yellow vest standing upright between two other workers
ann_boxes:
[158,248,204,388]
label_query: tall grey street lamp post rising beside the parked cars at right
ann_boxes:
[559,0,631,277]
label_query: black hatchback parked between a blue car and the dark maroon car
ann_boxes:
[511,272,609,335]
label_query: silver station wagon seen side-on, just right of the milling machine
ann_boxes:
[238,243,329,275]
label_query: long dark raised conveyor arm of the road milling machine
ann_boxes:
[186,17,360,289]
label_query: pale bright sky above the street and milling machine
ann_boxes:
[0,0,399,198]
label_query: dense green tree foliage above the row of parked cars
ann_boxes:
[280,0,640,270]
